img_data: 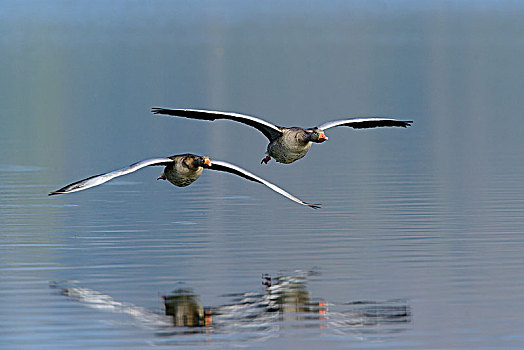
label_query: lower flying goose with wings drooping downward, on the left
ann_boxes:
[49,154,320,209]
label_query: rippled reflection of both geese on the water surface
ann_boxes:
[51,272,412,343]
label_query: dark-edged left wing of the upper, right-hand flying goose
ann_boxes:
[151,107,282,141]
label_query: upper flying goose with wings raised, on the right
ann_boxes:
[152,108,413,164]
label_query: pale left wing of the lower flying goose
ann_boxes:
[49,158,173,196]
